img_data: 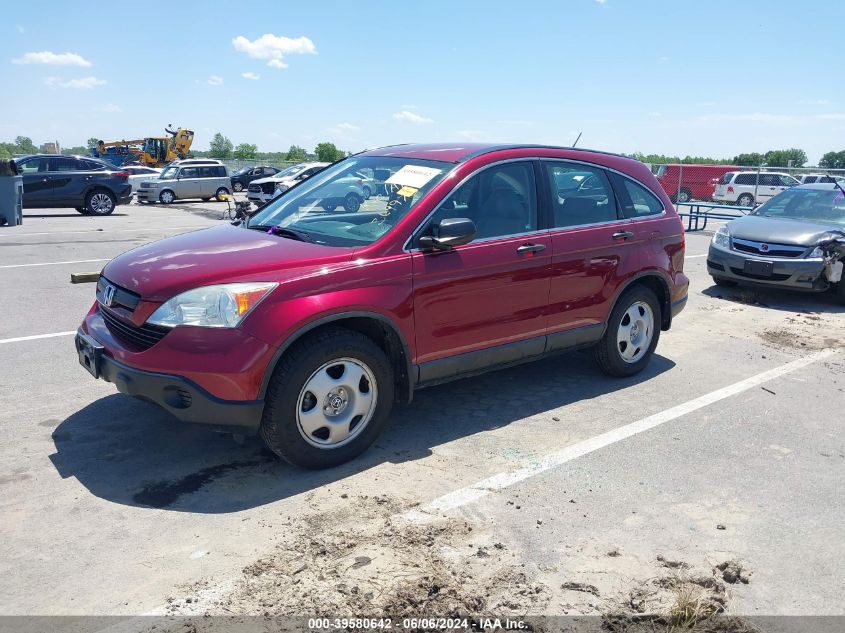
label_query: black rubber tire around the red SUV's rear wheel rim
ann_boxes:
[595,284,662,377]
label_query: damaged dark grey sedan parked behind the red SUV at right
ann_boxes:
[707,183,845,303]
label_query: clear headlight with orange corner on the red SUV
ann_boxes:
[147,282,279,328]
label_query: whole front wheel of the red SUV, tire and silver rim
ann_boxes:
[260,327,394,468]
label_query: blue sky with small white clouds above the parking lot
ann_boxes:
[0,0,845,163]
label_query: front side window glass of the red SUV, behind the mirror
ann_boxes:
[422,161,537,240]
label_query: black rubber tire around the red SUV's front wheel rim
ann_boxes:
[259,327,394,469]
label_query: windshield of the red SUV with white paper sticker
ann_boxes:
[249,156,452,246]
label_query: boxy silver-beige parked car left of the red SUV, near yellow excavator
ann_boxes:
[137,159,232,204]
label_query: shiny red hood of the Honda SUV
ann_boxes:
[103,224,354,301]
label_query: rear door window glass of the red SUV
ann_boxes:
[543,161,619,228]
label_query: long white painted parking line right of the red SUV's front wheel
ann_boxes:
[398,349,838,523]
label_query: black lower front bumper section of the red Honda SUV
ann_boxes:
[75,329,264,435]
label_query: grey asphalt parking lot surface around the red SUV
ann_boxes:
[0,203,845,615]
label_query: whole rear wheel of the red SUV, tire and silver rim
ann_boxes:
[596,285,661,377]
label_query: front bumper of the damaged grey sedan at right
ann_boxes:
[707,243,829,292]
